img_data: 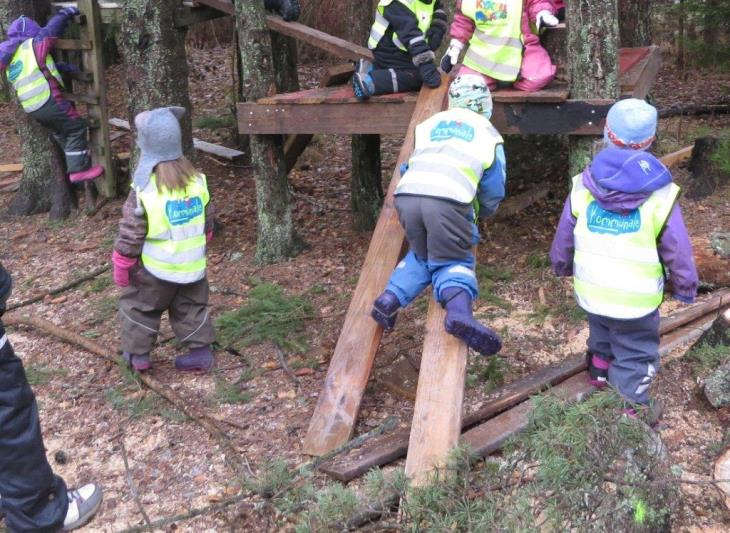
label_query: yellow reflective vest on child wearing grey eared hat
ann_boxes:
[137,174,210,284]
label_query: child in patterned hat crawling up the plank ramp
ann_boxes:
[371,71,506,355]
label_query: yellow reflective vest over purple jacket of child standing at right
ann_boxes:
[570,174,679,319]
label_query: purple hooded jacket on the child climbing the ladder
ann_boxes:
[0,11,79,118]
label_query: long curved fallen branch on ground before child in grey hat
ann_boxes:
[3,314,246,489]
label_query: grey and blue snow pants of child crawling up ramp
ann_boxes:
[386,195,479,307]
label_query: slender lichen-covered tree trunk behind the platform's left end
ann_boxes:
[236,0,301,264]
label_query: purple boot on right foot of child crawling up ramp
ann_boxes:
[441,287,502,355]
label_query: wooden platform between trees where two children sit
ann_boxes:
[238,47,660,135]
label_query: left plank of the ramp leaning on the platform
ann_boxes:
[303,75,448,455]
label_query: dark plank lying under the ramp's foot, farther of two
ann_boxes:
[319,355,585,482]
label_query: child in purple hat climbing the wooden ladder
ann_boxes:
[0,7,104,183]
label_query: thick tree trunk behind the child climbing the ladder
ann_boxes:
[0,0,77,220]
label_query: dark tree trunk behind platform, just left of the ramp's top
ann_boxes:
[347,1,384,231]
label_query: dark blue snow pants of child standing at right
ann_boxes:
[588,309,659,405]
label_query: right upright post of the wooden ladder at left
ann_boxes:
[78,0,117,197]
